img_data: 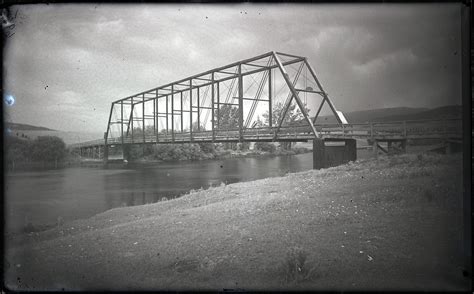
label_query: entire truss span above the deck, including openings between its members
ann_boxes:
[104,52,347,145]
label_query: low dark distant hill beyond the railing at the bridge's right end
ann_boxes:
[317,105,462,123]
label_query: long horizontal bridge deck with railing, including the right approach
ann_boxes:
[70,119,462,148]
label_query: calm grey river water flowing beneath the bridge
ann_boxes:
[4,153,324,233]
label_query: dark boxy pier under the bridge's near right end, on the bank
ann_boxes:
[313,138,357,169]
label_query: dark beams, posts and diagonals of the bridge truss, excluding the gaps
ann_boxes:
[104,51,343,145]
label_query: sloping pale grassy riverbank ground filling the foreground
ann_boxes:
[4,155,471,290]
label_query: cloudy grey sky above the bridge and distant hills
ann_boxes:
[4,4,461,132]
